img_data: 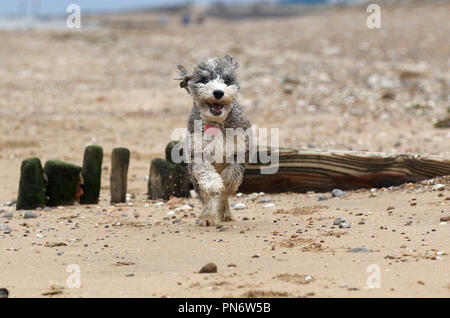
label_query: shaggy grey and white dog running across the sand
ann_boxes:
[178,56,251,226]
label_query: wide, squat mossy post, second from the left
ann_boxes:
[44,160,82,206]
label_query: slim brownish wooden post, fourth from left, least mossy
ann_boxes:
[110,148,130,203]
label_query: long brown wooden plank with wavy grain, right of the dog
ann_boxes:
[239,148,450,193]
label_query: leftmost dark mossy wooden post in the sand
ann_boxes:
[16,158,45,210]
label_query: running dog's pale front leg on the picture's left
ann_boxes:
[192,162,224,226]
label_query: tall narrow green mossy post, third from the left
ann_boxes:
[80,145,103,204]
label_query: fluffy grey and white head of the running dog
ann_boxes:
[178,55,239,122]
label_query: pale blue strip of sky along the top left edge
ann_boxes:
[0,0,282,15]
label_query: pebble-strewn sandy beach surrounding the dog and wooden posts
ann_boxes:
[0,4,450,297]
